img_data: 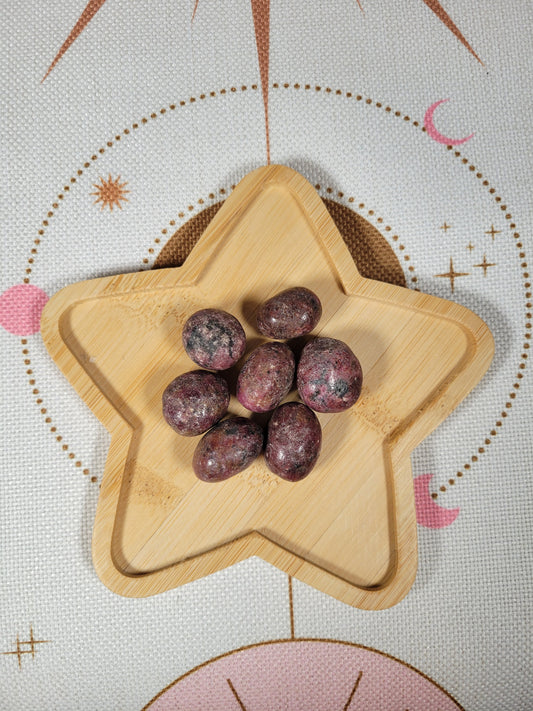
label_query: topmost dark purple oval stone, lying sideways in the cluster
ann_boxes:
[257,286,322,340]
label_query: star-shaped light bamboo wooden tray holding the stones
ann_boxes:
[42,166,493,609]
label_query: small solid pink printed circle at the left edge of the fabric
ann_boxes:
[0,284,48,336]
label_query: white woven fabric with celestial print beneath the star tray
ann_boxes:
[0,0,533,711]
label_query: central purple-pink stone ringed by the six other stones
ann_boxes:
[237,343,295,412]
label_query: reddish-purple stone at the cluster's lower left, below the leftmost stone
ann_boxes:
[192,417,263,482]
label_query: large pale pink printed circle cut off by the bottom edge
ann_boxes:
[143,639,462,711]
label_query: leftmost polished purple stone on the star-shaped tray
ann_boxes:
[162,370,230,437]
